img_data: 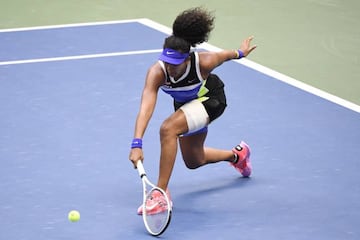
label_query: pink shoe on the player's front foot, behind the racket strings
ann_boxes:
[137,189,172,215]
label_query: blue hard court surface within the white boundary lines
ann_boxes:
[0,19,360,240]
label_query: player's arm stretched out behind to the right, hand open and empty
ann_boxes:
[199,36,257,76]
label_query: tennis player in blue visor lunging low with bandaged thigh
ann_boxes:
[129,7,256,214]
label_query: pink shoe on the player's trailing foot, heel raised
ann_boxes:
[231,141,251,177]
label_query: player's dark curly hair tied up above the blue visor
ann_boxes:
[164,7,215,52]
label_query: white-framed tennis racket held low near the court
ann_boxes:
[136,160,172,236]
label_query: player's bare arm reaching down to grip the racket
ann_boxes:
[129,63,165,166]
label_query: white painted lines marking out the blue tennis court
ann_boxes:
[0,18,360,113]
